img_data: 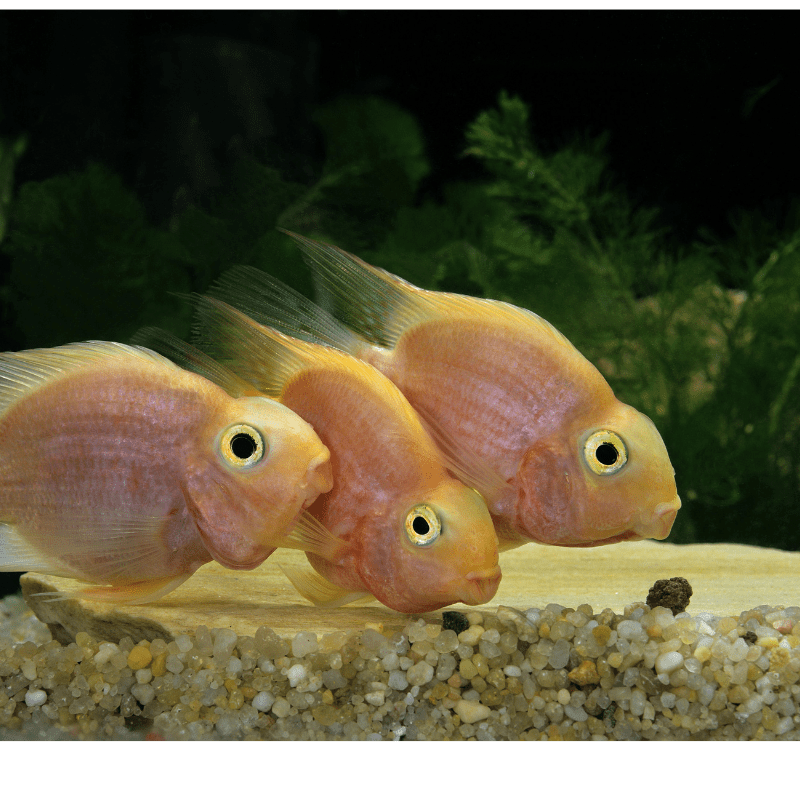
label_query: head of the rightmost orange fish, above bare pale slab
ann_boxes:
[516,401,681,547]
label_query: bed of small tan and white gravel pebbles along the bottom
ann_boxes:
[0,597,800,741]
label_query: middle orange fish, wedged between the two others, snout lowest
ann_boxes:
[191,298,500,612]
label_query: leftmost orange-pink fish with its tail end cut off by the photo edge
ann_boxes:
[0,342,332,602]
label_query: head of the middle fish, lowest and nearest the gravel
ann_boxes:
[362,478,501,613]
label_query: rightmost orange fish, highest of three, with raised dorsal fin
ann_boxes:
[214,234,681,549]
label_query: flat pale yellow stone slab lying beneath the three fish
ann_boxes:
[21,541,800,643]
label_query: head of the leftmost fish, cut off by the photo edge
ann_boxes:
[184,397,333,569]
